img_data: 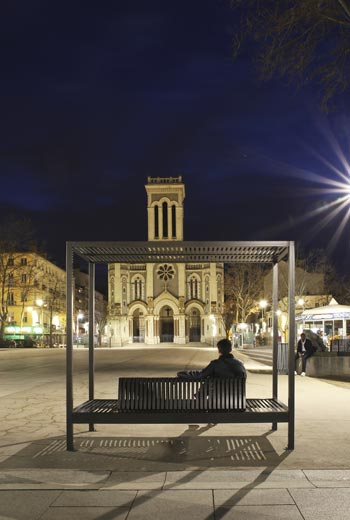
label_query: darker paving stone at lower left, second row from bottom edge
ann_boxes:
[52,490,136,507]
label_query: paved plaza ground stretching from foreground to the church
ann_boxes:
[0,346,350,520]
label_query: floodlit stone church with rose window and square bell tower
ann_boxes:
[107,176,225,346]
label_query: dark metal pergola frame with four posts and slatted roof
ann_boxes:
[66,241,295,450]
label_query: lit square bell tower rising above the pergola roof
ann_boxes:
[145,176,185,241]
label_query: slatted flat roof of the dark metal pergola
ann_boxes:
[71,241,288,264]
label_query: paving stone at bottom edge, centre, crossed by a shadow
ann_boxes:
[128,490,214,520]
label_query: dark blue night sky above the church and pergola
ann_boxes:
[0,0,350,280]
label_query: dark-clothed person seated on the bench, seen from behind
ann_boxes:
[177,339,247,379]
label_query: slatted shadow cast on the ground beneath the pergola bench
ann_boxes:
[0,425,285,471]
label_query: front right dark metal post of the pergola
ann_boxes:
[288,242,295,450]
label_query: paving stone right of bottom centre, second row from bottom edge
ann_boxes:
[214,489,294,507]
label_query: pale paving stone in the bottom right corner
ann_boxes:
[290,488,350,520]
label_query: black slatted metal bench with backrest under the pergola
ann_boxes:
[72,377,289,425]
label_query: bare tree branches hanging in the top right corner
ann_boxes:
[230,0,350,111]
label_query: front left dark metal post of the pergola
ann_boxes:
[66,242,74,451]
